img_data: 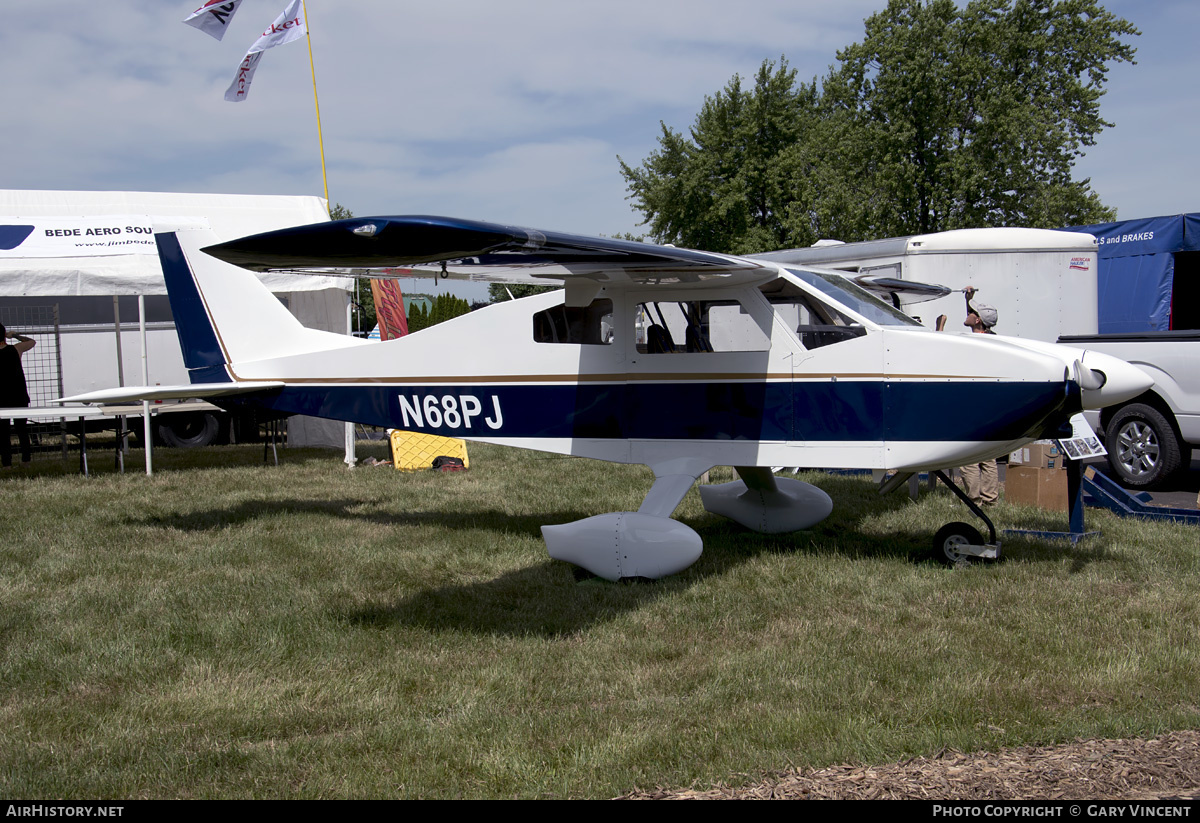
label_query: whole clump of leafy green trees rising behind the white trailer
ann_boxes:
[618,0,1138,253]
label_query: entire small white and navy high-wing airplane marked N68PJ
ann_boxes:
[64,216,1150,581]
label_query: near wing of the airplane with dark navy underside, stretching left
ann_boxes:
[203,215,773,283]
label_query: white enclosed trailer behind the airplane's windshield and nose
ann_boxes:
[755,228,1098,343]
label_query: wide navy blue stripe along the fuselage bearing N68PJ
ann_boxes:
[229,380,1080,443]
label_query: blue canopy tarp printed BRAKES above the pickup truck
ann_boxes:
[1066,214,1200,335]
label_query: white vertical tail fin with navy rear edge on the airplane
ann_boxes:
[155,225,359,384]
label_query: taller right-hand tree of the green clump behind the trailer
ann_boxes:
[823,0,1138,239]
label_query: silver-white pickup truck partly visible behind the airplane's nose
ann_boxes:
[1058,331,1200,488]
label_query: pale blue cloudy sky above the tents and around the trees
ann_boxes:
[0,0,1200,244]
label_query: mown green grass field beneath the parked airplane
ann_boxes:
[0,445,1200,798]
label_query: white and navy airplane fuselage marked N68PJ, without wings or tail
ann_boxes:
[216,272,1080,469]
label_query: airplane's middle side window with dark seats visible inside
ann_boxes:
[637,300,770,354]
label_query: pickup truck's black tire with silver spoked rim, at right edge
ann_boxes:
[1104,403,1183,488]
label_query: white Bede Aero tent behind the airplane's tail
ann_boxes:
[0,190,353,461]
